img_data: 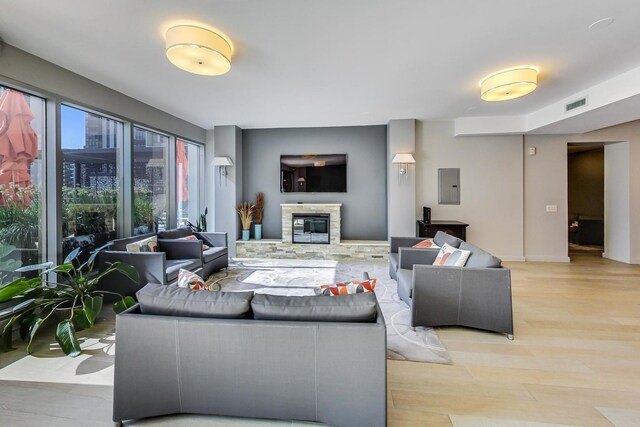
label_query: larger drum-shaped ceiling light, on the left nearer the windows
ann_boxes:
[166,25,231,76]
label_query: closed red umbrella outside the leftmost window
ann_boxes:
[0,89,38,206]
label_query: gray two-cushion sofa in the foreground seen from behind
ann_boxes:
[113,284,387,427]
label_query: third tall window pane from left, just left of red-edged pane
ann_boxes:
[133,126,169,234]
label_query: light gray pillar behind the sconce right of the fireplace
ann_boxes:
[387,119,420,236]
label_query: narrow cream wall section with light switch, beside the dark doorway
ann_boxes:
[523,135,569,262]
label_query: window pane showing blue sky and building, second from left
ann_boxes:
[60,105,124,256]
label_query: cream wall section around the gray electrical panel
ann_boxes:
[414,121,524,261]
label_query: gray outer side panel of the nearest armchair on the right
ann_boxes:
[411,265,513,334]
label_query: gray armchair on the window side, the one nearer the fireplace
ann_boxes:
[158,227,229,280]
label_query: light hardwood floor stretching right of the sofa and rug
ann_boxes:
[388,254,640,426]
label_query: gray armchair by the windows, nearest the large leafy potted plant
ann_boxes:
[98,234,202,301]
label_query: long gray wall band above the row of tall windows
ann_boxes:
[0,44,205,143]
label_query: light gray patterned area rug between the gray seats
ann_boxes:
[207,258,451,364]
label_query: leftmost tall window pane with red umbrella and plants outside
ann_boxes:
[0,86,46,264]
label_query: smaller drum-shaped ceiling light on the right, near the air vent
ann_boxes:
[480,65,539,101]
